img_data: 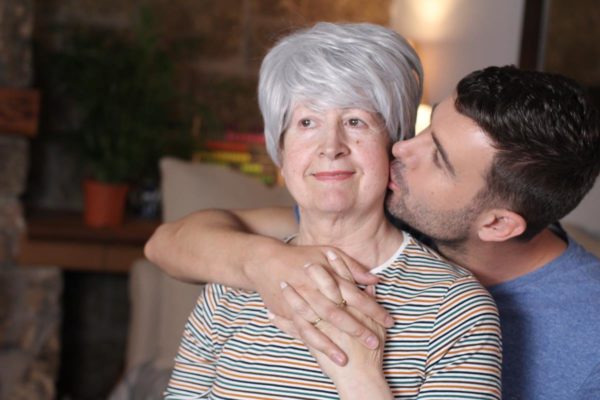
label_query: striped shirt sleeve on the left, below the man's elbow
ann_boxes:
[165,284,221,399]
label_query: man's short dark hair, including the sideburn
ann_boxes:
[455,66,600,240]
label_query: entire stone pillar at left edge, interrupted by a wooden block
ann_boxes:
[0,0,61,400]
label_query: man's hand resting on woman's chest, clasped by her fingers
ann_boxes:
[253,245,393,365]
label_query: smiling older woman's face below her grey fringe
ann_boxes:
[281,105,391,213]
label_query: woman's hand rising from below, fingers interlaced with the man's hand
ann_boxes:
[273,286,393,400]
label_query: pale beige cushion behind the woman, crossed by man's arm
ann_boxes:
[148,157,294,367]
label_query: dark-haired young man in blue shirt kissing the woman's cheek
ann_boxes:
[147,67,600,399]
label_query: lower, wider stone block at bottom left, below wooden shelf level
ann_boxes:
[0,267,62,400]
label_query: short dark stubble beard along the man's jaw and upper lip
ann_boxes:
[386,160,482,251]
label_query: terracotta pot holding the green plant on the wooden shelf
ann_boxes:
[83,179,129,228]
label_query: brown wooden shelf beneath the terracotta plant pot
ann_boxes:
[18,211,160,273]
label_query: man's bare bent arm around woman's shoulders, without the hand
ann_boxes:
[144,208,298,289]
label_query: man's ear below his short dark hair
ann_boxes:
[477,208,527,242]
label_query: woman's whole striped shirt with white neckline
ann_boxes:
[166,233,502,400]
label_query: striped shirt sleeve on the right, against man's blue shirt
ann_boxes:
[418,277,502,400]
